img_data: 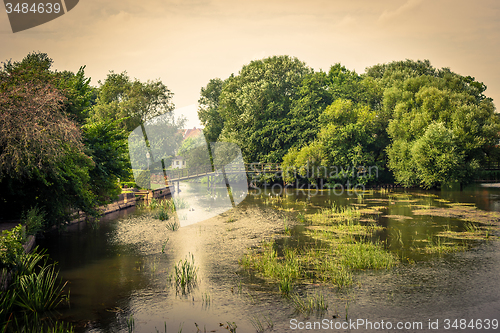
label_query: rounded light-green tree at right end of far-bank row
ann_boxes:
[374,60,500,188]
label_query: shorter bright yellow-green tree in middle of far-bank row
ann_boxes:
[283,99,385,183]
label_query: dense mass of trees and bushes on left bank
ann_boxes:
[0,53,177,227]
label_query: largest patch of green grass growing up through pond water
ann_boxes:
[240,200,398,290]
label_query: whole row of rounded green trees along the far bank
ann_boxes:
[199,56,500,188]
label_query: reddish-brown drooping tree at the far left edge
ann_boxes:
[0,54,95,223]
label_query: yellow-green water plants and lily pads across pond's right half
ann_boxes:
[238,190,500,318]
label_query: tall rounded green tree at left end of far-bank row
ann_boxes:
[218,56,312,162]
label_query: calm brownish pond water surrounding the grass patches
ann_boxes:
[41,185,500,332]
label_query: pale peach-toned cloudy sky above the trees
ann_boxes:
[0,0,500,127]
